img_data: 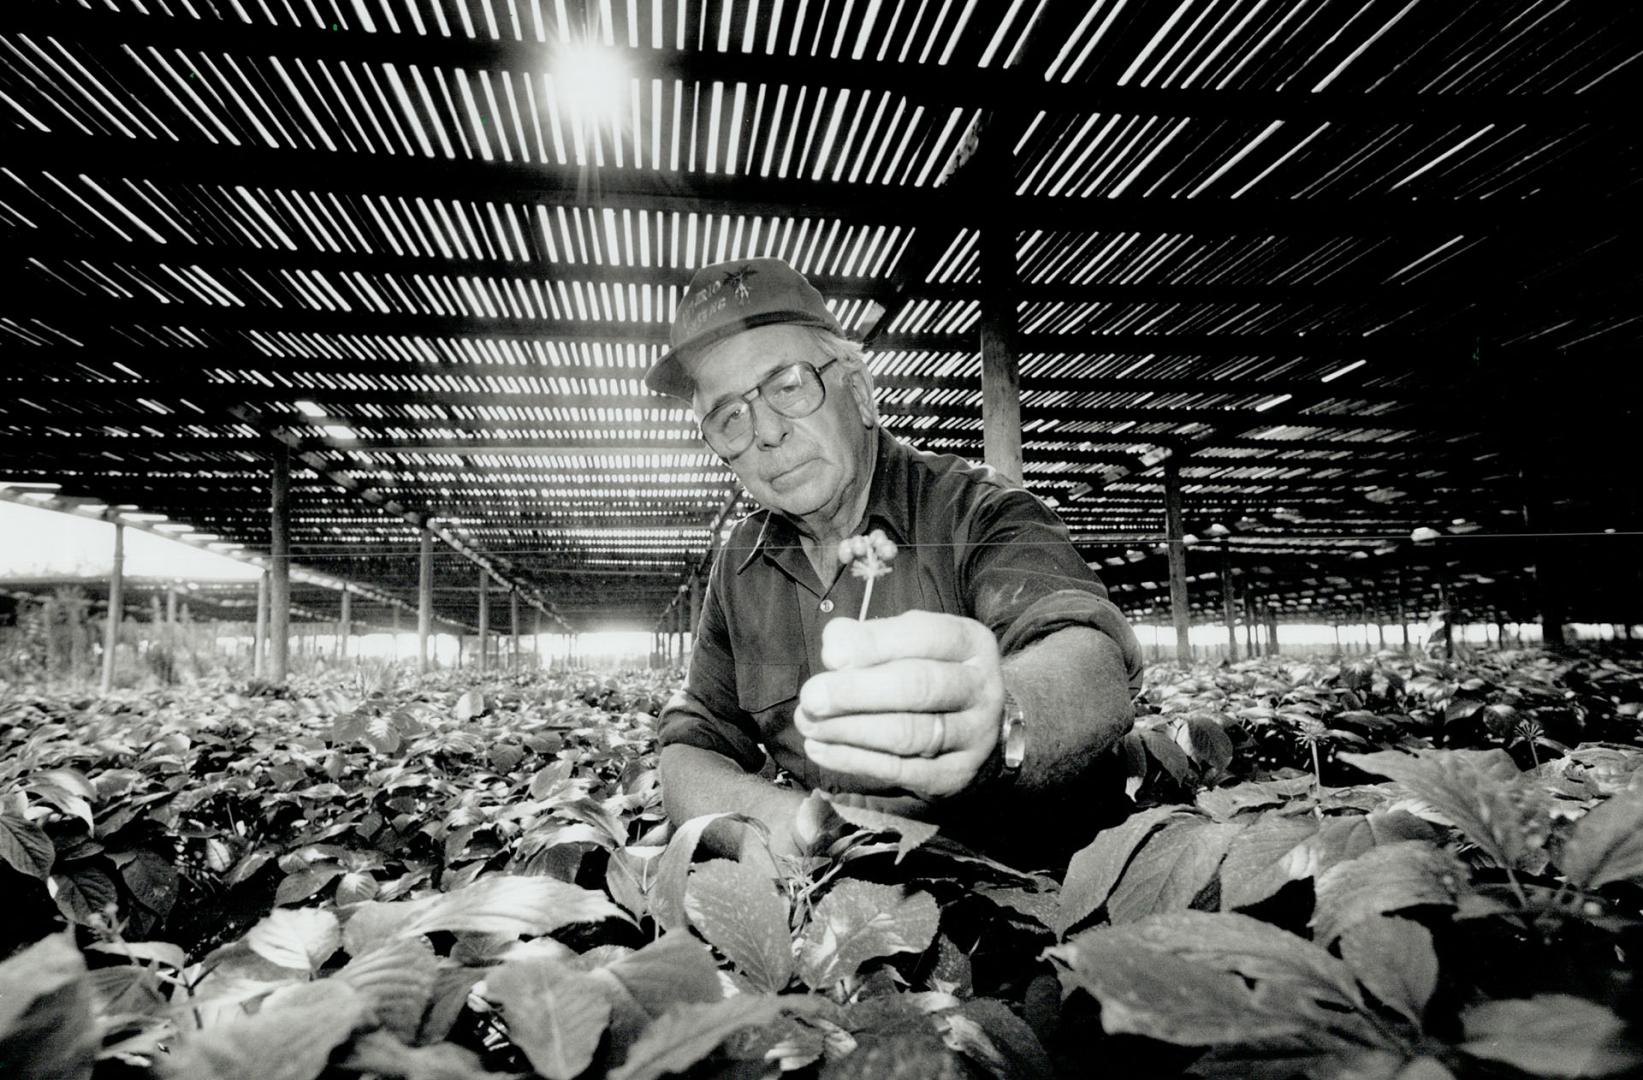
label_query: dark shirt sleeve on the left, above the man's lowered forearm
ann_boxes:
[659,554,764,773]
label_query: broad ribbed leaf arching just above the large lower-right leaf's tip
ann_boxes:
[1313,840,1467,944]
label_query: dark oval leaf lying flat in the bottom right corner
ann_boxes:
[1461,995,1643,1077]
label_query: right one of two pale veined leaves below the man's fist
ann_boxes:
[800,878,941,990]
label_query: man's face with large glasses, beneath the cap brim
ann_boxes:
[690,324,874,528]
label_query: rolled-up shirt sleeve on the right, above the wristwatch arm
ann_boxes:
[958,488,1144,692]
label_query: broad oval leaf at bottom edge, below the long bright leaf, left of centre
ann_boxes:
[485,958,611,1080]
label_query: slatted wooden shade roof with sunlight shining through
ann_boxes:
[0,0,1643,630]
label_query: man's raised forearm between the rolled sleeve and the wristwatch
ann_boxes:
[1004,626,1135,794]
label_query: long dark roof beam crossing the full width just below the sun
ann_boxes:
[0,130,1623,237]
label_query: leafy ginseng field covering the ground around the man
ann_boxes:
[0,654,1643,1080]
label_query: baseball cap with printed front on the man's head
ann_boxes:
[644,258,845,401]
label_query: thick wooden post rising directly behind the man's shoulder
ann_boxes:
[981,191,1022,485]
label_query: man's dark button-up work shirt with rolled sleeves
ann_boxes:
[660,429,1142,792]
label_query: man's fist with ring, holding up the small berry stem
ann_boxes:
[794,612,1004,799]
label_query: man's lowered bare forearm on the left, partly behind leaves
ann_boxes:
[657,745,805,856]
